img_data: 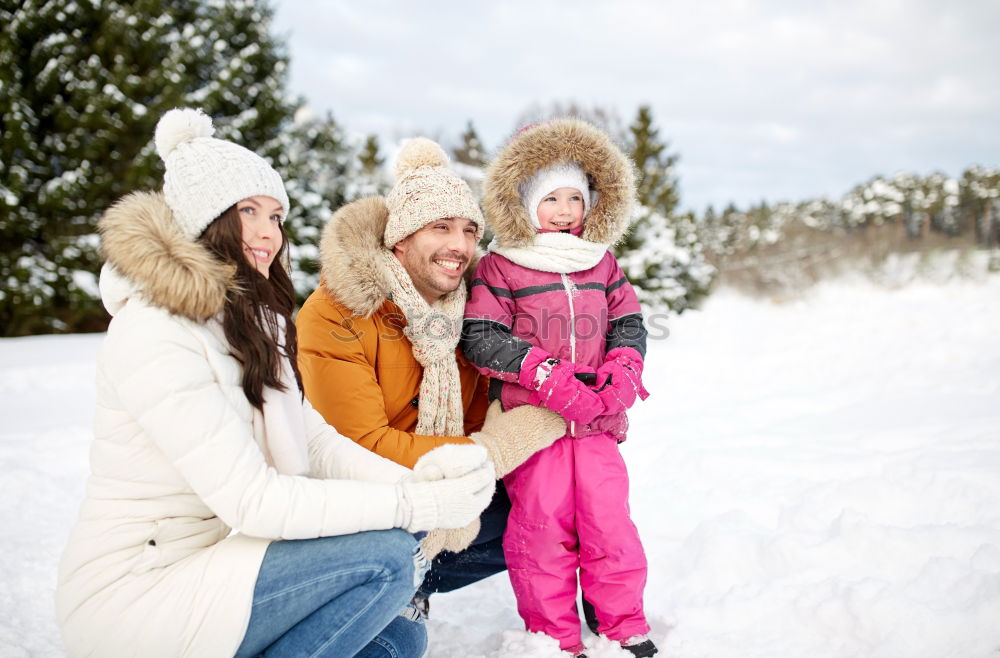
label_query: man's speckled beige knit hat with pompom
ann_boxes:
[384,137,484,249]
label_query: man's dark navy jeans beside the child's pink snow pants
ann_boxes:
[420,480,510,597]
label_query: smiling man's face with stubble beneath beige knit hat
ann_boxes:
[393,217,477,304]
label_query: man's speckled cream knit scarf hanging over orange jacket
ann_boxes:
[379,249,465,436]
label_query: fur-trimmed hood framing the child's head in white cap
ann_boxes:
[483,118,636,247]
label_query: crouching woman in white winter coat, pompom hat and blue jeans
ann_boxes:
[56,110,494,657]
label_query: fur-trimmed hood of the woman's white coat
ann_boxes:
[98,192,234,322]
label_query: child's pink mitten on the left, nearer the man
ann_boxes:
[518,347,607,424]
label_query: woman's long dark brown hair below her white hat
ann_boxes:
[198,205,302,409]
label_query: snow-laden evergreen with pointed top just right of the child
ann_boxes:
[615,106,715,312]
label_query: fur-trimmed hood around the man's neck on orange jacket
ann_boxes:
[319,197,479,317]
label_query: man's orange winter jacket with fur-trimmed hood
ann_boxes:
[295,198,489,468]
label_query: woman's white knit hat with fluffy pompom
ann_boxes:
[155,108,288,239]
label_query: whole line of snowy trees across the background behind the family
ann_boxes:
[0,0,1000,336]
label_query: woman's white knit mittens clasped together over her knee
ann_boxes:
[396,445,495,532]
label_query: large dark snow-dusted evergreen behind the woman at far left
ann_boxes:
[0,0,292,335]
